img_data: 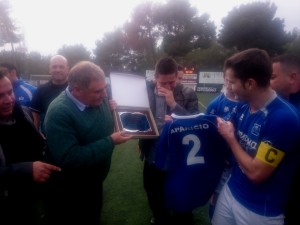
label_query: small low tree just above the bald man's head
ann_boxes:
[58,44,91,67]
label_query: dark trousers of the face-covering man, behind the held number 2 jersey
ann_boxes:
[143,161,193,225]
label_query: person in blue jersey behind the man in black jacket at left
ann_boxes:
[0,62,36,107]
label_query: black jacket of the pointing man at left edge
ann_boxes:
[0,104,46,197]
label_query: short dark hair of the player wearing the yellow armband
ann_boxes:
[224,48,272,87]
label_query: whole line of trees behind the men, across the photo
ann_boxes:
[0,0,300,78]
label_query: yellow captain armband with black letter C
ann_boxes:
[255,142,285,167]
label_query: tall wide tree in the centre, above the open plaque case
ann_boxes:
[107,0,216,73]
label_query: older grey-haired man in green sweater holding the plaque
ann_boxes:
[45,61,131,225]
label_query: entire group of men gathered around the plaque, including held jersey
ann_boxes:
[0,48,300,225]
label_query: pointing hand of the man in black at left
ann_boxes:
[33,161,61,183]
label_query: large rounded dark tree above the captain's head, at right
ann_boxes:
[219,2,288,54]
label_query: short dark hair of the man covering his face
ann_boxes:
[155,57,178,77]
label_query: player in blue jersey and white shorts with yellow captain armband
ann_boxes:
[212,48,300,225]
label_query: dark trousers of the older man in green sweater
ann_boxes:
[44,181,103,225]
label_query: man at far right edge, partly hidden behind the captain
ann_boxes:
[271,54,300,225]
